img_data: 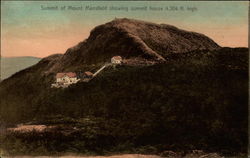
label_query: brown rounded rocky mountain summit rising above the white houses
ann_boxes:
[45,18,220,72]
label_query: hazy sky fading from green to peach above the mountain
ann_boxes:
[1,1,249,57]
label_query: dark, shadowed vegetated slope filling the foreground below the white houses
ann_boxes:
[0,48,248,154]
